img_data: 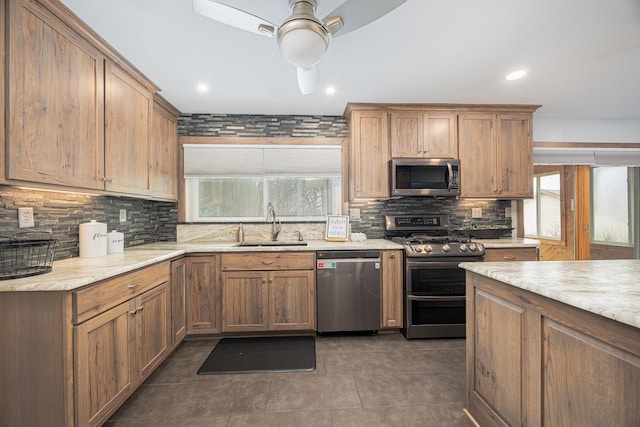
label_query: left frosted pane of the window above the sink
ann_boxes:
[198,178,264,218]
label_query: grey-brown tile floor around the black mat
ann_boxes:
[106,332,473,427]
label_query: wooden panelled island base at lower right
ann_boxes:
[466,272,640,427]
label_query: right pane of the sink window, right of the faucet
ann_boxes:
[268,177,340,217]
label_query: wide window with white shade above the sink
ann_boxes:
[184,145,342,222]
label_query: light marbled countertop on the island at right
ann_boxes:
[460,260,640,328]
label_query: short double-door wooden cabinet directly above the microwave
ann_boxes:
[390,111,458,158]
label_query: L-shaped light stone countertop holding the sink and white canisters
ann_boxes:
[0,239,402,292]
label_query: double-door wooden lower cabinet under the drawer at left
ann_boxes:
[74,282,170,426]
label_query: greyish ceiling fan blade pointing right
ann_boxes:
[322,0,407,37]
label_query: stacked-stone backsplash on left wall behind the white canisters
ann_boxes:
[0,187,178,260]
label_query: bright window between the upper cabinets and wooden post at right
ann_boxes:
[524,172,562,240]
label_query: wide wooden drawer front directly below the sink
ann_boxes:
[221,252,315,271]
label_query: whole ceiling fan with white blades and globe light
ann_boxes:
[193,0,407,95]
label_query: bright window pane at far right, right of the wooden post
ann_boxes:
[591,167,629,244]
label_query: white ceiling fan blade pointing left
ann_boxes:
[193,0,278,37]
